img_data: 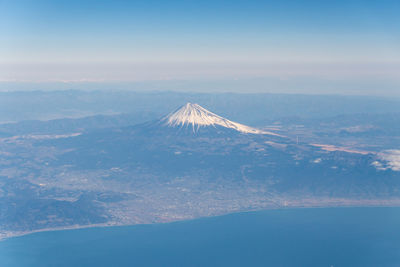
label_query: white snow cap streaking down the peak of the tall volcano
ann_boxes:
[162,103,280,136]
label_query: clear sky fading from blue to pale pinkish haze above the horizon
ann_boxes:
[0,0,400,93]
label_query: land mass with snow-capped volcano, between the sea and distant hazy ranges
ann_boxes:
[0,104,400,241]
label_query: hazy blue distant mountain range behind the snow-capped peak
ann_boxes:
[0,88,400,125]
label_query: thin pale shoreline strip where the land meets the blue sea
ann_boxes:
[0,203,400,242]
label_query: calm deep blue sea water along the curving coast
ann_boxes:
[0,208,400,267]
